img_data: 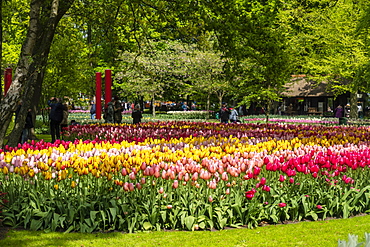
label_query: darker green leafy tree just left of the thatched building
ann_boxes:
[199,0,292,120]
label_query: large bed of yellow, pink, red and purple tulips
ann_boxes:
[0,121,370,232]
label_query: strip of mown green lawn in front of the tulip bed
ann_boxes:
[0,215,370,247]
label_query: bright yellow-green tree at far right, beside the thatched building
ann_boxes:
[295,1,369,118]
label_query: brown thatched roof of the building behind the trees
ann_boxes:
[282,75,334,97]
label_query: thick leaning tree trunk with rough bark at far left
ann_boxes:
[0,0,74,149]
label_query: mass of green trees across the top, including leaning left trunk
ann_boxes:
[0,0,370,145]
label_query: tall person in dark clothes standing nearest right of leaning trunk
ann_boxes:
[48,97,63,143]
